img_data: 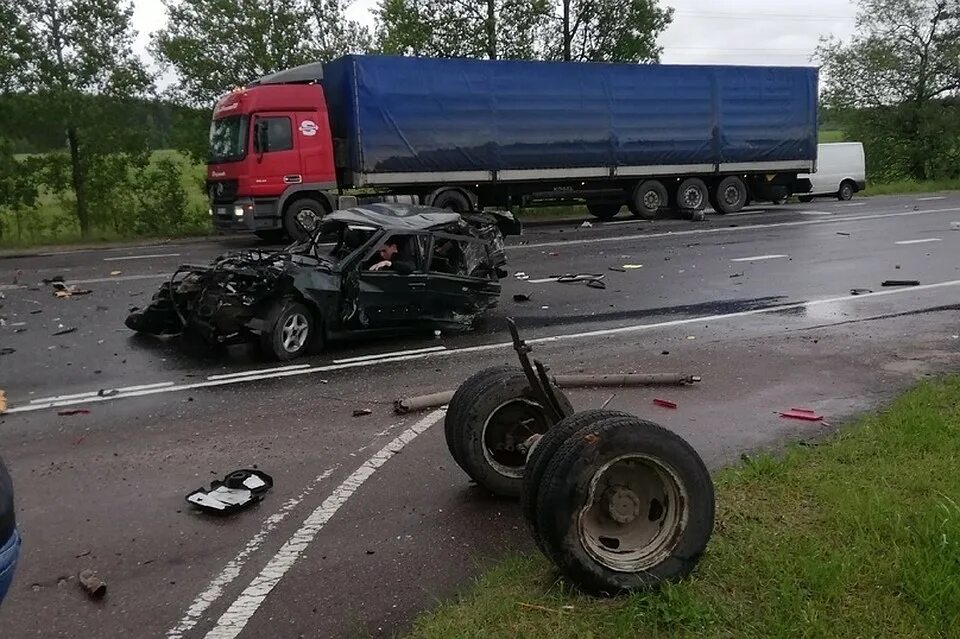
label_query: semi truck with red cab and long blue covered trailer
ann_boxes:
[206,55,818,239]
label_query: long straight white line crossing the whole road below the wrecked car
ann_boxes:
[5,280,960,415]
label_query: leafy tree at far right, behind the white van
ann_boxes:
[818,0,960,180]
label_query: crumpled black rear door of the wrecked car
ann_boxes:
[427,233,500,324]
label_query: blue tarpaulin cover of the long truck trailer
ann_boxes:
[323,56,817,173]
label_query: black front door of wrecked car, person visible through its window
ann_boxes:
[357,232,429,329]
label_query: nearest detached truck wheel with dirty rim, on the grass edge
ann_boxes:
[534,417,715,595]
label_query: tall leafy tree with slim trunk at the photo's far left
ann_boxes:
[11,0,152,237]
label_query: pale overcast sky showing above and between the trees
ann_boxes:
[133,0,856,74]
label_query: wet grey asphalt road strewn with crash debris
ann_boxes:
[0,195,960,637]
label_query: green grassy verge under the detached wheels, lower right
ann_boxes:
[411,377,960,639]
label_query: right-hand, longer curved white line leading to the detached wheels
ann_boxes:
[206,409,446,639]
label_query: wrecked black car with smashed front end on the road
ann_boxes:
[126,204,520,360]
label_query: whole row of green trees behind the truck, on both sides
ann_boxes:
[0,0,960,240]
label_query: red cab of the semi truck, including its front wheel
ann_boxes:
[206,65,337,240]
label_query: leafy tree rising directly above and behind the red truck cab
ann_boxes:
[153,0,369,108]
